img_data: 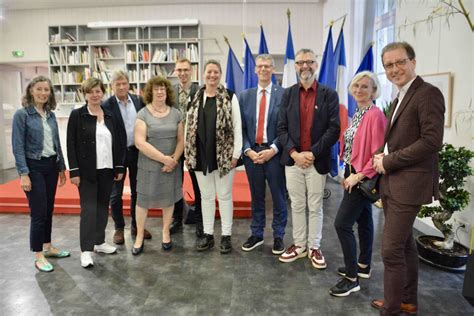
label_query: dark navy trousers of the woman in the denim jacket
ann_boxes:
[25,156,59,252]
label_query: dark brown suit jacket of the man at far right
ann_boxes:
[380,77,445,205]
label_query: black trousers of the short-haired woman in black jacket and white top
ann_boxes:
[79,169,114,251]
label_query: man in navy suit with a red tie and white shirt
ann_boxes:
[239,54,287,255]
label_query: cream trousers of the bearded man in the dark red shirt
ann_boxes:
[285,166,326,248]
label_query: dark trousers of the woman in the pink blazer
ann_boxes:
[334,168,374,278]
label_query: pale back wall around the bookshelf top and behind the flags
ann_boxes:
[0,3,323,68]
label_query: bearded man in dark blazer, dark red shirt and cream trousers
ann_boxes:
[278,49,340,269]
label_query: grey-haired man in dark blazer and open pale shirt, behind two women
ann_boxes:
[103,71,151,245]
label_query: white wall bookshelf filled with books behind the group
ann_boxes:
[48,20,202,115]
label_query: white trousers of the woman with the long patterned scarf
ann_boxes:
[196,169,235,236]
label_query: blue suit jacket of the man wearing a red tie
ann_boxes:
[239,84,284,153]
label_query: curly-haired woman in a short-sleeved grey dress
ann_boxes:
[132,77,184,255]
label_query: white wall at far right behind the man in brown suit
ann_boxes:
[396,0,474,245]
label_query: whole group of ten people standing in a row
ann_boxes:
[13,42,444,315]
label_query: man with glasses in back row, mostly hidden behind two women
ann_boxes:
[170,58,204,237]
